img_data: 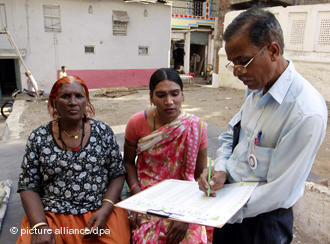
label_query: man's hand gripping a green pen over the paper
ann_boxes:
[198,168,227,197]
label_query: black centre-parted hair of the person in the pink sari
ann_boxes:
[149,68,183,93]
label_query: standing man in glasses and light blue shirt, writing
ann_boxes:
[199,8,328,244]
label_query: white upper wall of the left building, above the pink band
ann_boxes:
[0,0,171,90]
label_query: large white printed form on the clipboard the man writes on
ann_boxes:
[115,180,258,228]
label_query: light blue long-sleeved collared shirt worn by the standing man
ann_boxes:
[215,61,328,223]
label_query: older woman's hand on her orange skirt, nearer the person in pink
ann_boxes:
[84,202,114,238]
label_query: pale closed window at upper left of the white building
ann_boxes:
[43,5,61,32]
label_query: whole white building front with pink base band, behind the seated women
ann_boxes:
[0,0,171,97]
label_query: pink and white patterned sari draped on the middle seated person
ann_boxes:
[132,113,206,244]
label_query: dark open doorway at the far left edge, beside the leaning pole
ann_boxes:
[0,59,18,98]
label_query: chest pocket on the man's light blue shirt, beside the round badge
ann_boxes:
[254,146,274,180]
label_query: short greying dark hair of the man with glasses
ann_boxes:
[223,7,284,54]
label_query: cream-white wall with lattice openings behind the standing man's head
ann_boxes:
[219,4,330,101]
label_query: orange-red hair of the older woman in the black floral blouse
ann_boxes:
[47,75,95,118]
